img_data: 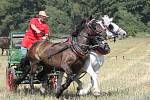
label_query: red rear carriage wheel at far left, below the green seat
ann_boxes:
[6,68,17,91]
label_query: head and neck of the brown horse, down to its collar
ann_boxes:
[72,18,109,55]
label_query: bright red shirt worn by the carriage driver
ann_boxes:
[22,18,49,48]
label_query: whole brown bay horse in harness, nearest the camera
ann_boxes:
[24,19,105,98]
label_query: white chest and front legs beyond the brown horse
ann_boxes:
[76,51,104,96]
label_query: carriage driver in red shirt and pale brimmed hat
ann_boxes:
[21,11,51,56]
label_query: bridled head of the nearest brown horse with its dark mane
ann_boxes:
[72,17,107,44]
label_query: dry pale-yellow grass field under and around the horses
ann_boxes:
[0,38,150,100]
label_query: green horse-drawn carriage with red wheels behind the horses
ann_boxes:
[6,32,59,91]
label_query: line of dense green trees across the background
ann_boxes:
[0,0,150,36]
